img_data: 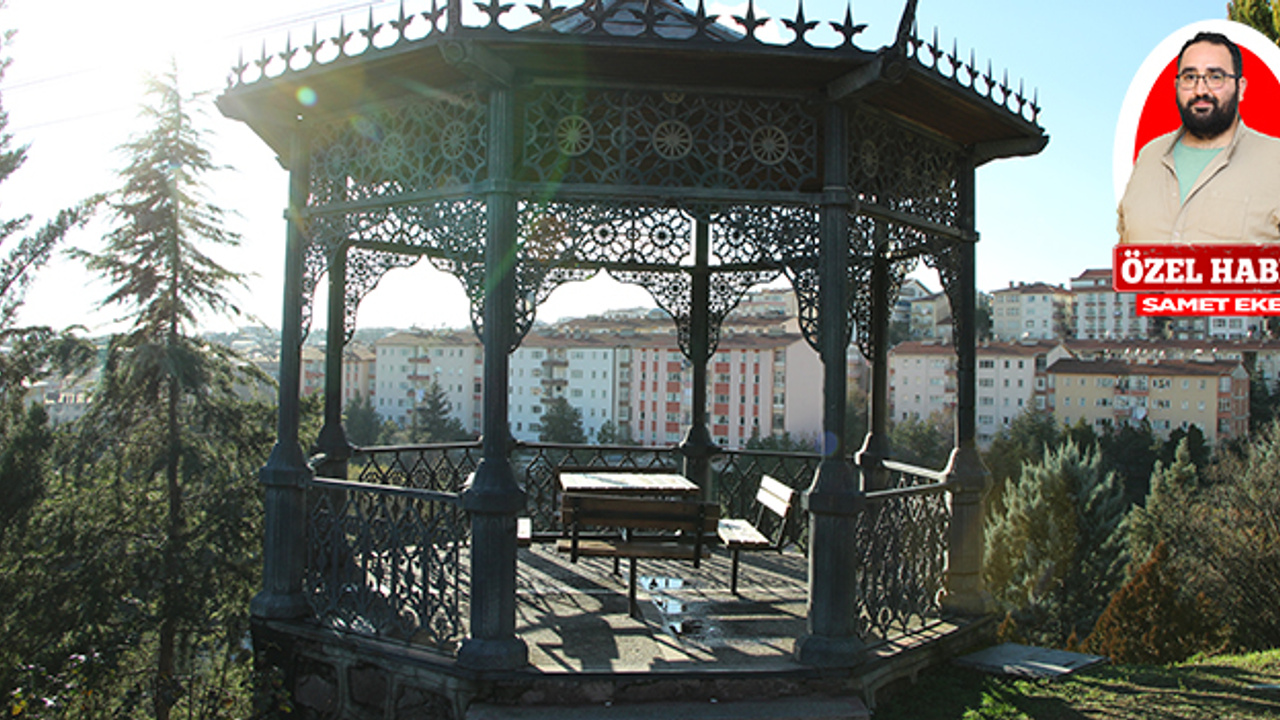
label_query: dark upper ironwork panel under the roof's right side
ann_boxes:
[849,106,960,227]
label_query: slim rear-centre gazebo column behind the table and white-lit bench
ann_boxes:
[680,220,719,500]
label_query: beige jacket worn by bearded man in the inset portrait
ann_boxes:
[1116,122,1280,245]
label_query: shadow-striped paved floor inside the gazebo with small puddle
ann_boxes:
[516,543,808,673]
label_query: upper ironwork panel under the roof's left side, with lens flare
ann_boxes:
[308,92,489,208]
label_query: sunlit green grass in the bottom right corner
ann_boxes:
[876,650,1280,720]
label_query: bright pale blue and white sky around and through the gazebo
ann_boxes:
[0,0,1225,334]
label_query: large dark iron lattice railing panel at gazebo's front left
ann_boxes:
[305,487,470,652]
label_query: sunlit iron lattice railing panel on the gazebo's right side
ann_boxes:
[854,478,951,639]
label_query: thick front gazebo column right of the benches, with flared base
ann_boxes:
[795,102,865,666]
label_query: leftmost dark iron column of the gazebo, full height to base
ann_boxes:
[250,120,311,620]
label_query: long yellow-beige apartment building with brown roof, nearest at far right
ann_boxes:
[1047,357,1249,443]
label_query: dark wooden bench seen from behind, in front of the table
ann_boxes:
[556,493,719,618]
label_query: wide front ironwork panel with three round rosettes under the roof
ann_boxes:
[518,88,818,191]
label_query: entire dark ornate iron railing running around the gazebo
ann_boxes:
[306,442,951,653]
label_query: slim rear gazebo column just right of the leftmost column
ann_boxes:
[316,245,351,479]
